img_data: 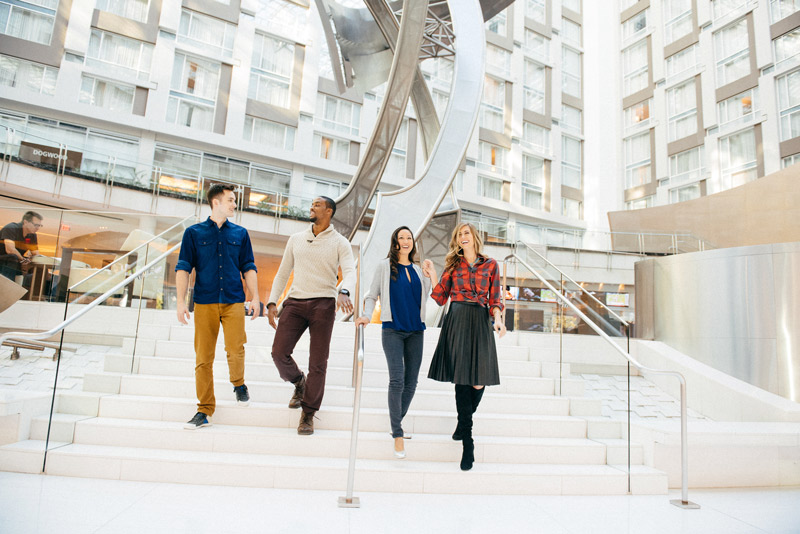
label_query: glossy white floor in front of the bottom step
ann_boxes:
[0,472,800,534]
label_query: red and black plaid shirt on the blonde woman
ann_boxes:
[431,256,503,314]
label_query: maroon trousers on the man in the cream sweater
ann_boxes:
[272,298,336,412]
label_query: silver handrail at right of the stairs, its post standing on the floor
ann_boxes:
[503,254,699,508]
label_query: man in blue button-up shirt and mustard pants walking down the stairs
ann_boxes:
[175,184,261,429]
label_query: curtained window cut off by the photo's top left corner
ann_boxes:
[0,0,58,45]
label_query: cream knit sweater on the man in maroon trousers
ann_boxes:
[267,225,355,304]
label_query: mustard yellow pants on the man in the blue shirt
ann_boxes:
[194,302,247,415]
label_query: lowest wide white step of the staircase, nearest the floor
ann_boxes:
[0,437,667,495]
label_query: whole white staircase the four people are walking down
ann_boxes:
[0,318,667,495]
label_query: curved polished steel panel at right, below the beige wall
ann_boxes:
[636,243,800,402]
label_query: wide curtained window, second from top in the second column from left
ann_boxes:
[86,29,153,80]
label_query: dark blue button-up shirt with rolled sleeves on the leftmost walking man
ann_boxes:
[175,217,256,304]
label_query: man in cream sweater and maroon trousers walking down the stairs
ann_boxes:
[267,197,355,435]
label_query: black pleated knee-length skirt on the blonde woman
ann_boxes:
[428,302,500,386]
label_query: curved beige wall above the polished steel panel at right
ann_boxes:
[608,165,800,248]
